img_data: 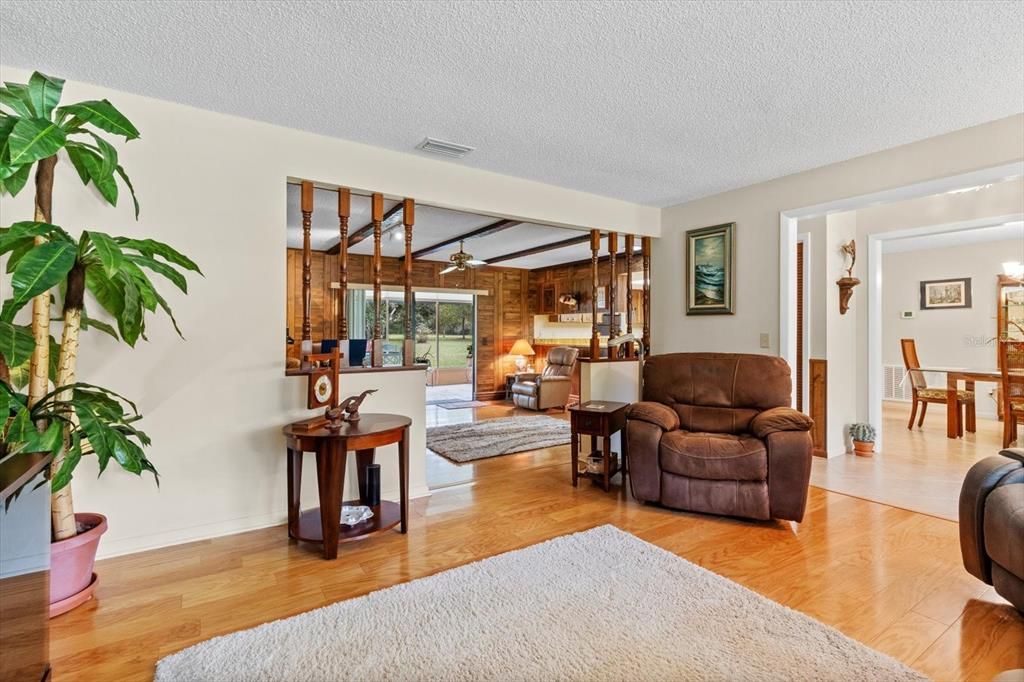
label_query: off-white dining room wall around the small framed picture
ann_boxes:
[882,240,1024,417]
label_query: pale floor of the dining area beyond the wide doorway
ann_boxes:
[811,402,1002,521]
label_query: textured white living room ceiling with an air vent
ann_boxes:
[0,0,1024,206]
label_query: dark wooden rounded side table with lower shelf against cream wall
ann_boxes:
[283,414,413,559]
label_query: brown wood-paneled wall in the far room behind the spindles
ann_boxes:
[286,249,532,399]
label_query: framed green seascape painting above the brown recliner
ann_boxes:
[686,222,736,315]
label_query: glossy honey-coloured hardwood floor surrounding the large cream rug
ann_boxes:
[51,406,1024,682]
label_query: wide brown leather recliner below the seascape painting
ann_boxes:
[626,353,813,521]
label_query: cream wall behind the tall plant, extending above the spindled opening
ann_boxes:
[0,67,660,555]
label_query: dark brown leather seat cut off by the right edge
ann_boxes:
[959,447,1024,612]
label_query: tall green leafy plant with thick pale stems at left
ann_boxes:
[0,72,200,540]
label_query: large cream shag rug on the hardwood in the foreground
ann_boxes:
[156,525,925,682]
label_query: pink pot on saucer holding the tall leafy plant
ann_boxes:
[50,513,106,619]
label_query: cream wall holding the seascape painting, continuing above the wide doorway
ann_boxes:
[651,115,1024,354]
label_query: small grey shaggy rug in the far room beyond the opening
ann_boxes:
[427,415,571,463]
